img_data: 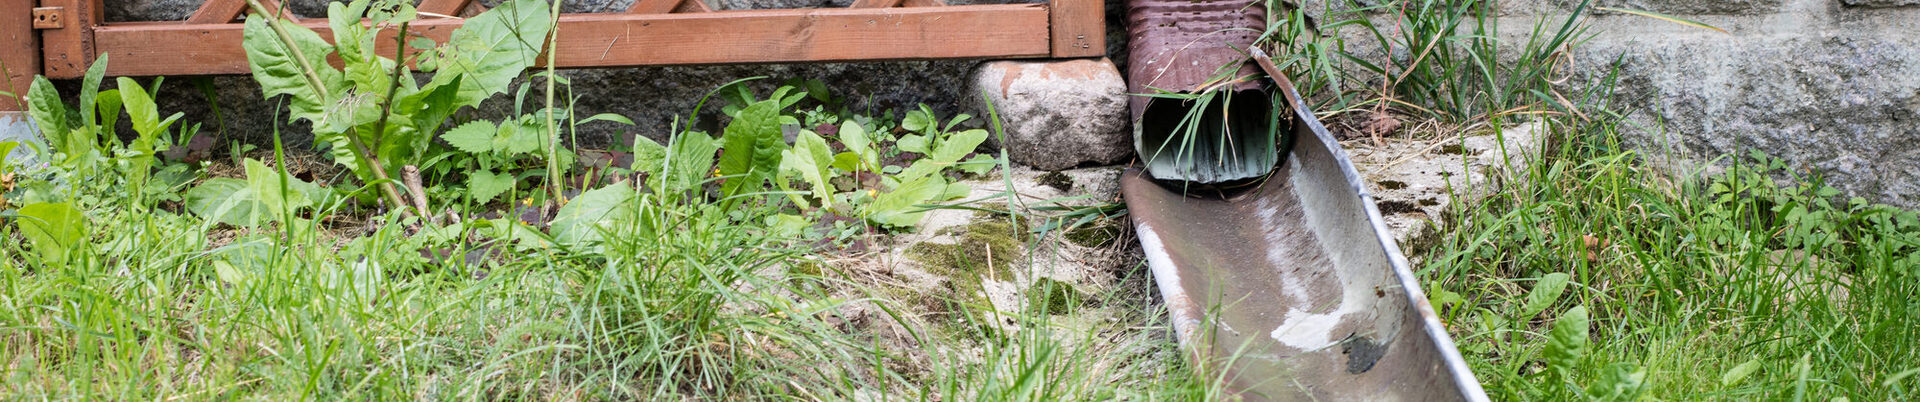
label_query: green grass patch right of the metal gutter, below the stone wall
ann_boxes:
[1419,112,1920,400]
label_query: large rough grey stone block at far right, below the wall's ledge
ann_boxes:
[1578,35,1920,208]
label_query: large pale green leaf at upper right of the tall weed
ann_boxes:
[432,0,553,106]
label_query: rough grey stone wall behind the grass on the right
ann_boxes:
[1308,0,1920,208]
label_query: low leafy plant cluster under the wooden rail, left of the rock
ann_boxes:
[632,81,998,229]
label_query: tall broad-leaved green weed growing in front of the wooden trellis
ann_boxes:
[234,0,555,215]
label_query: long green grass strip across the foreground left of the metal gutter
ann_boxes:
[0,99,1219,400]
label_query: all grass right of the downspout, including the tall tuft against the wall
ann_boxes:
[1267,0,1920,400]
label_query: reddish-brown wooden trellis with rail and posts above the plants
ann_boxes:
[0,0,1106,110]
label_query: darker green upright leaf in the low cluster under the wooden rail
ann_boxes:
[720,100,787,196]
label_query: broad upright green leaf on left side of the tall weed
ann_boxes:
[244,15,346,121]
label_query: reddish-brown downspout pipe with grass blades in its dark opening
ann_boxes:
[1127,0,1284,183]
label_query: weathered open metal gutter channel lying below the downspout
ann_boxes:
[1121,71,1486,400]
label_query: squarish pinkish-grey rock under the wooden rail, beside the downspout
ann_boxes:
[970,60,1133,171]
